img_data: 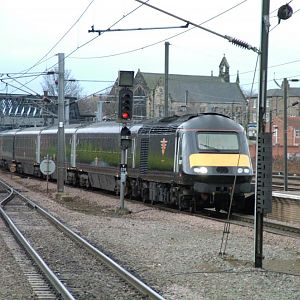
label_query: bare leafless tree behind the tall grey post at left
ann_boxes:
[41,68,83,98]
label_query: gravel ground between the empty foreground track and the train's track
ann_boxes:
[0,174,300,300]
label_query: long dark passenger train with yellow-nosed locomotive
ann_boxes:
[0,113,254,211]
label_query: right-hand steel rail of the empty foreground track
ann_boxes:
[3,180,164,300]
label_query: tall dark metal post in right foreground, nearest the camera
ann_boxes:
[254,0,270,268]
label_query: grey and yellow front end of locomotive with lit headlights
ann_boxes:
[182,115,253,210]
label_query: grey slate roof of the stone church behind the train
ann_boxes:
[140,72,245,103]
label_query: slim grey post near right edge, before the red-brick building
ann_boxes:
[283,78,288,191]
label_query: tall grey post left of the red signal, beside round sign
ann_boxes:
[57,53,65,193]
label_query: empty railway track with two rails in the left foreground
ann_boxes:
[0,179,163,299]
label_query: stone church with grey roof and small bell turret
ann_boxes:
[106,55,247,125]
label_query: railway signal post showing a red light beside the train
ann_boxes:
[118,71,134,210]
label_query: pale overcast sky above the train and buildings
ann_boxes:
[0,0,300,95]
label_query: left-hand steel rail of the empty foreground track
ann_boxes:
[0,182,75,300]
